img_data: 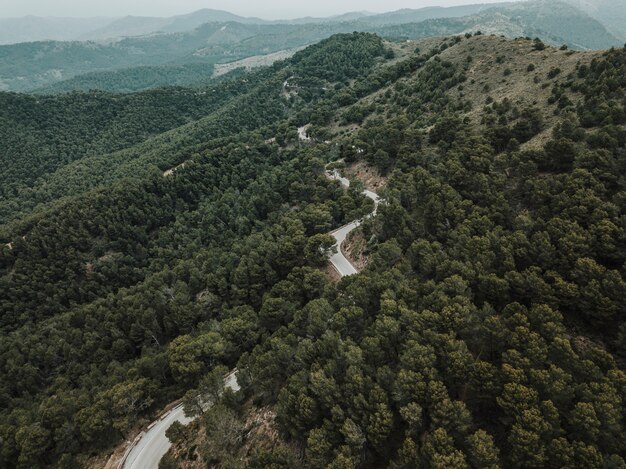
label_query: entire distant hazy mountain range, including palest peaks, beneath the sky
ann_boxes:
[0,0,623,91]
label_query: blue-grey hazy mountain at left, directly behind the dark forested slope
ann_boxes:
[0,23,354,91]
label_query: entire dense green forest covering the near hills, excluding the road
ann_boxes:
[0,33,626,468]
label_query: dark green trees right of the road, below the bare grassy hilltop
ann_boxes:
[232,44,626,468]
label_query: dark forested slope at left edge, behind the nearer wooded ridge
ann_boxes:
[0,72,250,208]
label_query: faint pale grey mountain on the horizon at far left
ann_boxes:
[0,16,115,45]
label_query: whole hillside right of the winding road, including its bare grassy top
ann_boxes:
[162,36,626,468]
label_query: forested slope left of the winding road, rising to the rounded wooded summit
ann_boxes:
[0,34,384,467]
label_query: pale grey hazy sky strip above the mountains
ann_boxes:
[0,0,502,19]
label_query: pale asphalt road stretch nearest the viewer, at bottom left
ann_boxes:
[121,371,239,469]
